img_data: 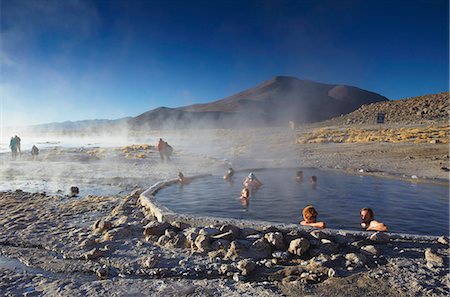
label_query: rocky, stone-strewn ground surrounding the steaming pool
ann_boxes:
[0,95,450,296]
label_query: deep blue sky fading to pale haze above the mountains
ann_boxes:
[0,0,449,126]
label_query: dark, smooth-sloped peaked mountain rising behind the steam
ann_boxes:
[129,76,388,128]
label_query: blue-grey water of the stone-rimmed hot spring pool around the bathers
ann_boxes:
[156,169,449,235]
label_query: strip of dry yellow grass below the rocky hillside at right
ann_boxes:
[296,125,449,144]
